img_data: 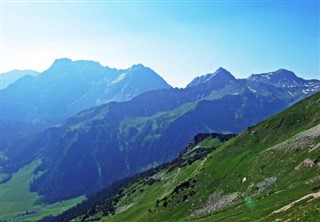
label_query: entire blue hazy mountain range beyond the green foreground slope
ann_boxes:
[0,59,320,208]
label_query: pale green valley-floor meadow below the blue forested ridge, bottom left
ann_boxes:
[0,161,84,221]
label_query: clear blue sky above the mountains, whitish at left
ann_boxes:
[1,0,320,87]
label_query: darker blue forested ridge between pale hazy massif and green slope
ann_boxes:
[5,64,320,202]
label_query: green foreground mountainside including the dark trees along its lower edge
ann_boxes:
[48,93,320,222]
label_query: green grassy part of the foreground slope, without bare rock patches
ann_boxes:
[78,93,320,221]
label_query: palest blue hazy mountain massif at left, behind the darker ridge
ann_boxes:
[0,59,171,180]
